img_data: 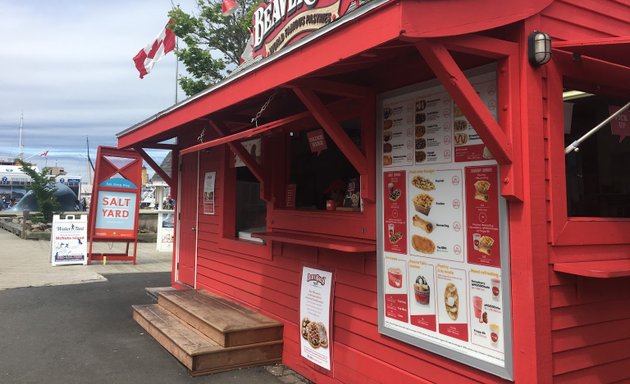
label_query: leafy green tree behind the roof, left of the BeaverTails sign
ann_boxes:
[168,0,261,96]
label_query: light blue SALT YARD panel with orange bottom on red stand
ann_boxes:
[94,190,137,239]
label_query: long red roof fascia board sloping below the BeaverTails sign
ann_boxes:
[117,2,401,148]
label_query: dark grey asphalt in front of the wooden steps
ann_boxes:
[0,273,281,384]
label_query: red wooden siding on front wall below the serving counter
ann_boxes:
[197,148,502,384]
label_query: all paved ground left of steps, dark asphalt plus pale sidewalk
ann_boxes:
[0,230,306,384]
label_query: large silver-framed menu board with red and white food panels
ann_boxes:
[377,71,511,378]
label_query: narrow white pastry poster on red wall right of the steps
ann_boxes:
[300,267,333,371]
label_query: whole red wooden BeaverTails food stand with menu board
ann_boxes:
[118,0,630,383]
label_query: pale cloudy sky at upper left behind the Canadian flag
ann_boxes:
[0,0,194,181]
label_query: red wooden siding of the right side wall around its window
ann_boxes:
[541,0,630,383]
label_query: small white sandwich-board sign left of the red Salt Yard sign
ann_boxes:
[50,215,88,266]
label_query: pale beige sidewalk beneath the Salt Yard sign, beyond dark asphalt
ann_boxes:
[0,230,172,290]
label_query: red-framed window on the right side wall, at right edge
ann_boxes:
[546,56,630,246]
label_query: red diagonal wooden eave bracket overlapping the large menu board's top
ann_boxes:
[416,40,523,201]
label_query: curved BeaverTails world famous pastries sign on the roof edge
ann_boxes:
[241,0,367,64]
